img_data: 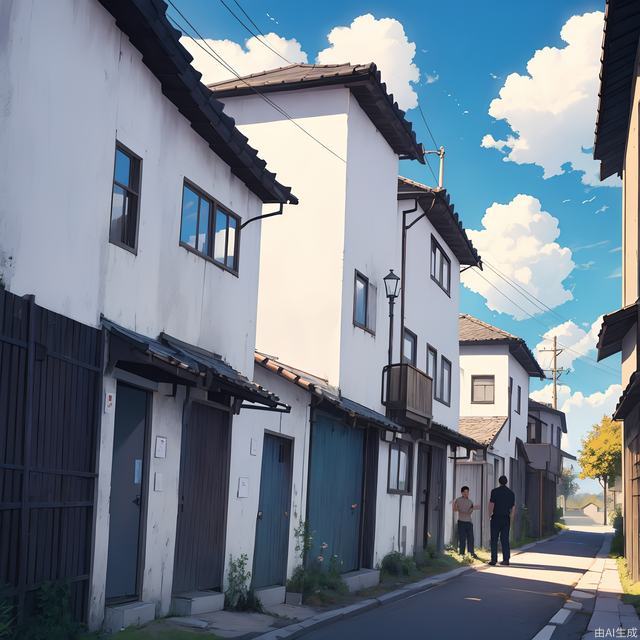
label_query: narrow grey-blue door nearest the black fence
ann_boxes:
[106,384,148,601]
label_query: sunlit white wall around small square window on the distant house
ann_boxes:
[460,345,510,416]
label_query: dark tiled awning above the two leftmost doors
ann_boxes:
[102,318,282,407]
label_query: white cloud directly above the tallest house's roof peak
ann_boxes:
[317,13,420,111]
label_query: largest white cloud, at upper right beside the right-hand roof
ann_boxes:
[481,11,620,186]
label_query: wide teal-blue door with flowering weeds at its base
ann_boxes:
[307,412,364,573]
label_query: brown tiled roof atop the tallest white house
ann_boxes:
[209,62,424,164]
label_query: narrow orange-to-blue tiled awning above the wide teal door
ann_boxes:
[255,351,406,433]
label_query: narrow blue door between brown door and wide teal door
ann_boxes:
[253,433,291,589]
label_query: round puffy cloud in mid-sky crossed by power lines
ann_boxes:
[462,194,575,320]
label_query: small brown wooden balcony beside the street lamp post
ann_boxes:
[382,364,433,427]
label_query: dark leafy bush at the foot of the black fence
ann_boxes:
[19,582,81,640]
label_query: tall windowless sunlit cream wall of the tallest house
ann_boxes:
[219,88,350,385]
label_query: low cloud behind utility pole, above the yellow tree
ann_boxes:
[530,384,622,455]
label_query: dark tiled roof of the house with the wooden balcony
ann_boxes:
[398,176,482,267]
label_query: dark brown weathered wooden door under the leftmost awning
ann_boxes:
[173,402,230,593]
